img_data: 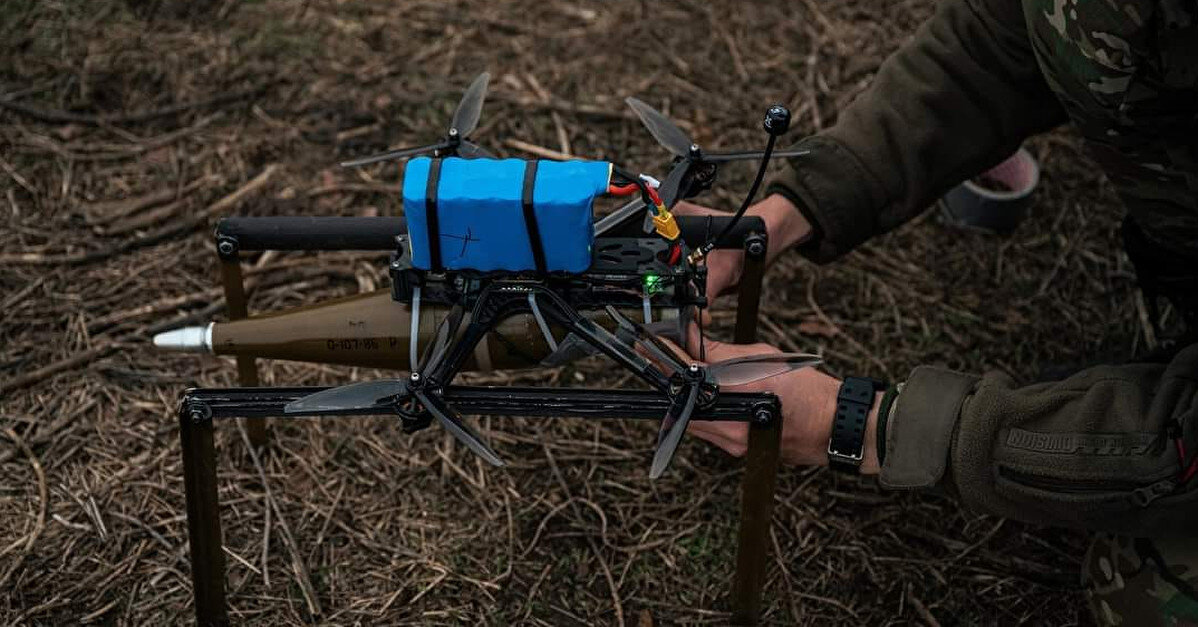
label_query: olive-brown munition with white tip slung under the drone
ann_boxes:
[153,290,677,370]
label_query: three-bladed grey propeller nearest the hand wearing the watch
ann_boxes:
[607,307,823,480]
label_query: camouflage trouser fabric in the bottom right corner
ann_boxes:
[1082,533,1198,627]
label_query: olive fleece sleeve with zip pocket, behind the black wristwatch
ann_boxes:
[881,344,1198,537]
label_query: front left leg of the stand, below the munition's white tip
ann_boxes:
[179,406,229,627]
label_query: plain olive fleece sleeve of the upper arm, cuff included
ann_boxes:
[768,0,1065,263]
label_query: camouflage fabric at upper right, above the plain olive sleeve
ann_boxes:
[1023,0,1198,259]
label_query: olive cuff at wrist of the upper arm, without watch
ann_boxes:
[766,135,882,264]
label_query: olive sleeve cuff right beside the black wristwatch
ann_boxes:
[879,366,978,490]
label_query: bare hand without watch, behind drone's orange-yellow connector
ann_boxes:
[673,194,811,300]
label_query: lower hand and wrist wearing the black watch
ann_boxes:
[674,325,881,475]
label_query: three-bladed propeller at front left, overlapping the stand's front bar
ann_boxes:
[283,304,503,466]
